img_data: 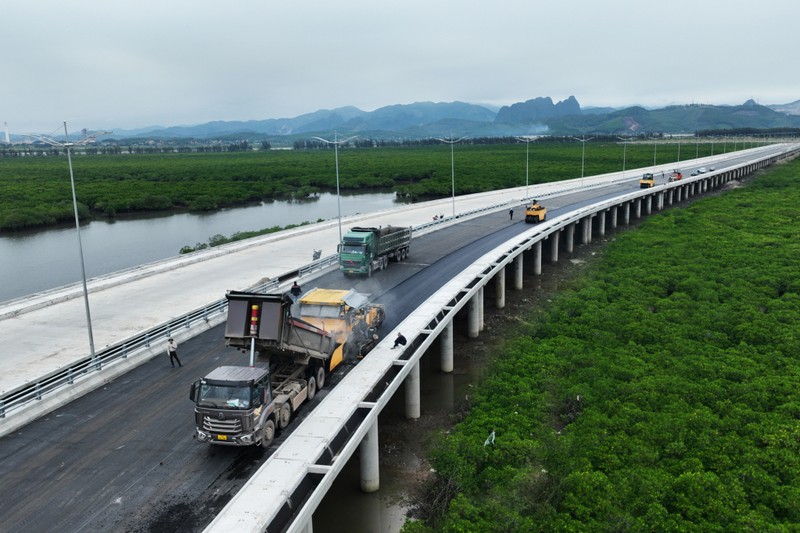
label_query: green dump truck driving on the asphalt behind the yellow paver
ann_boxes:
[339,226,411,277]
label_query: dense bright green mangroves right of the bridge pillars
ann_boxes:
[404,157,800,533]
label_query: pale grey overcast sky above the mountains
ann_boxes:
[0,0,800,134]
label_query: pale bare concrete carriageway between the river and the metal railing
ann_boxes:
[0,182,576,395]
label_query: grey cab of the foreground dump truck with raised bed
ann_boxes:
[189,366,275,448]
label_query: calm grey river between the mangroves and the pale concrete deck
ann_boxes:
[0,193,398,302]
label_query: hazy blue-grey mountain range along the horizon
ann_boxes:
[109,96,800,141]
